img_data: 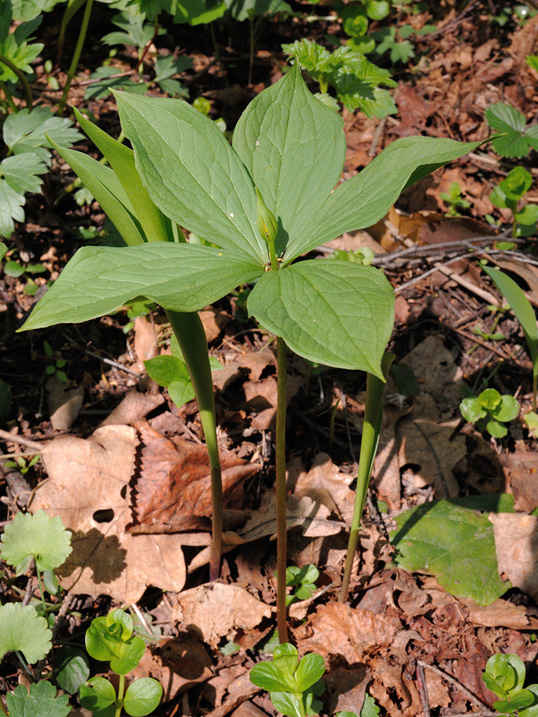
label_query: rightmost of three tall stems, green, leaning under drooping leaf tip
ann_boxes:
[338,353,394,602]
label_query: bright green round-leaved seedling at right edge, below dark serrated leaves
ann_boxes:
[489,166,538,237]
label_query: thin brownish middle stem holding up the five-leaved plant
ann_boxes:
[276,338,288,643]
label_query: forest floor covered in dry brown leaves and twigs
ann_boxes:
[0,0,538,717]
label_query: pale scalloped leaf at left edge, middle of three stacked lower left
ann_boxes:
[0,603,52,664]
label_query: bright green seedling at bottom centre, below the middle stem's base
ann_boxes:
[249,643,325,717]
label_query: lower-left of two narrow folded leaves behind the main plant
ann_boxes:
[49,144,146,246]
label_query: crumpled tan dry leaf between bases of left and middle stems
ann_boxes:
[174,583,272,647]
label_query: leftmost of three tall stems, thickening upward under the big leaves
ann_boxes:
[166,311,220,580]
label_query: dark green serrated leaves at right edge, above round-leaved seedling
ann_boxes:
[486,102,538,157]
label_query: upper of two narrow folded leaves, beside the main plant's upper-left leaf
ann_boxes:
[74,109,174,241]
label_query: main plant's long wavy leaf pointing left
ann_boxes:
[24,242,262,330]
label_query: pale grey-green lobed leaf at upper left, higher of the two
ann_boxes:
[3,107,82,166]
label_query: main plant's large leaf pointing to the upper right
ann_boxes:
[285,137,482,261]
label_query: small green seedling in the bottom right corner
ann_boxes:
[482,654,538,717]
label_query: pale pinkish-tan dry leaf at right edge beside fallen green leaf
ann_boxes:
[489,513,538,600]
